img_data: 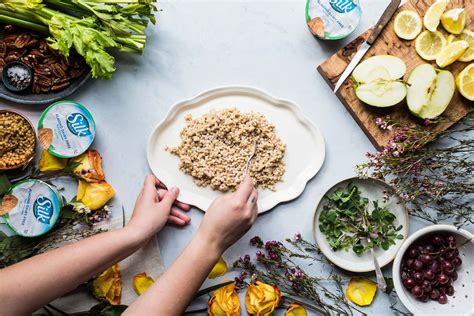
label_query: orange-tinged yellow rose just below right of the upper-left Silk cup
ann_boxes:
[71,149,105,182]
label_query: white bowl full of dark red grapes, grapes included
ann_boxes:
[393,225,474,316]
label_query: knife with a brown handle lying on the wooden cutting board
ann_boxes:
[334,0,401,93]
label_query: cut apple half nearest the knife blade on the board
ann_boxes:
[352,55,407,107]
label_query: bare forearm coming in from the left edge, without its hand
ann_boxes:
[0,228,145,315]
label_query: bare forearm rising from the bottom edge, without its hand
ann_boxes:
[124,233,223,315]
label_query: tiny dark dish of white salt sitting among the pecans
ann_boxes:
[2,61,33,92]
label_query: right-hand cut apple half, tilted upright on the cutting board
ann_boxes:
[407,64,455,119]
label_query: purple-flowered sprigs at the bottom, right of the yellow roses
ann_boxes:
[233,234,365,315]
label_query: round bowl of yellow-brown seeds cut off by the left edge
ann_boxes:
[0,110,36,170]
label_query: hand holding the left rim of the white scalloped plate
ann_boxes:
[126,175,191,240]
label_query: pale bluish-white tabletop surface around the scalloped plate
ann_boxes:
[0,0,458,315]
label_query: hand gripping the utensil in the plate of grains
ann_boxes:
[198,175,258,252]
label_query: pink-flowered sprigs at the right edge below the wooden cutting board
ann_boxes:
[356,111,474,227]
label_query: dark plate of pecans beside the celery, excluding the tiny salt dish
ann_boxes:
[0,25,90,104]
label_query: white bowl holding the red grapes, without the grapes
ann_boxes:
[393,225,474,316]
